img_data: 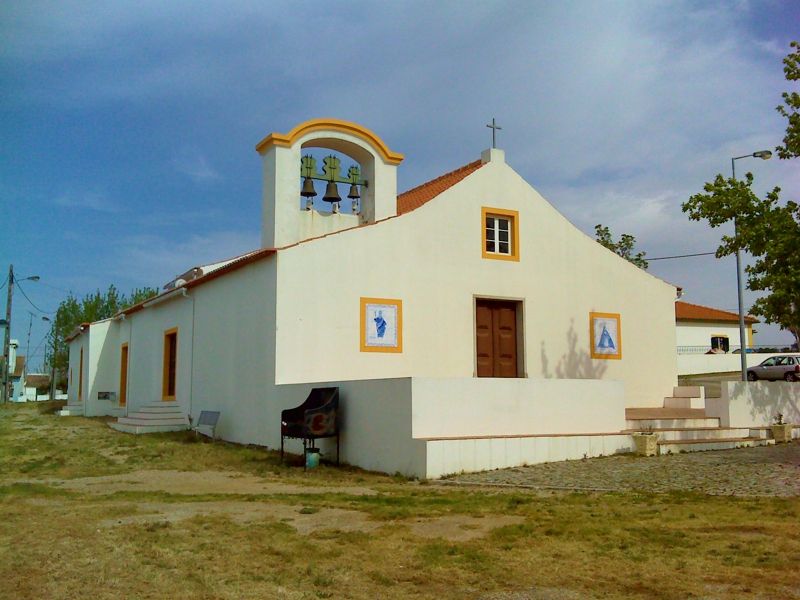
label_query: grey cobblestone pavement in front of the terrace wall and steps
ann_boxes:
[441,441,800,497]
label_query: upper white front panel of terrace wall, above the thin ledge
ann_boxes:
[411,377,625,439]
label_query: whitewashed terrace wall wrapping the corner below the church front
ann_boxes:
[268,378,631,478]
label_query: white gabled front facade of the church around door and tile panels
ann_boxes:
[276,160,677,406]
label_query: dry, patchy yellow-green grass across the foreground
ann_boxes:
[0,406,800,600]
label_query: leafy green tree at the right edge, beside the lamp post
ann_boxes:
[683,42,800,344]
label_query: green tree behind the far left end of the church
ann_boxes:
[45,285,158,386]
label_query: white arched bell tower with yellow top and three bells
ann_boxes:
[256,119,403,248]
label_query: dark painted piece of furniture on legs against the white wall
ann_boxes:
[281,387,339,465]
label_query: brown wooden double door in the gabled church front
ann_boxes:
[475,300,519,377]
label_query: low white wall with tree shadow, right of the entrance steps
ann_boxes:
[706,381,800,427]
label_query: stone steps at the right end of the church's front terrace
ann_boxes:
[625,386,775,454]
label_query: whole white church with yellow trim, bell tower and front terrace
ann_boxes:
[67,119,792,477]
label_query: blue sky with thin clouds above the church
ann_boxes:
[0,0,800,362]
